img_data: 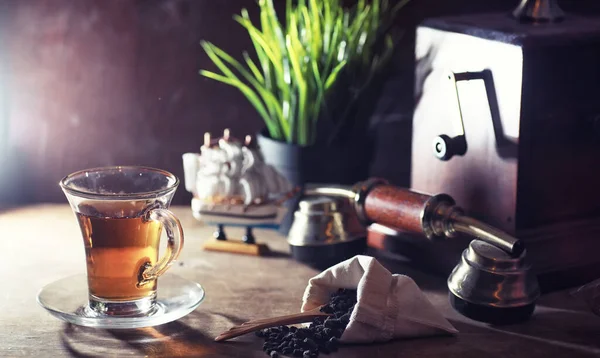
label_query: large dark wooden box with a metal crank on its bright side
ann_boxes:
[411,0,600,291]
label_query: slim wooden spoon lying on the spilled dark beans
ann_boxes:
[215,306,331,342]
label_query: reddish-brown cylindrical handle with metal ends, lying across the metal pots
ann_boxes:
[307,178,525,256]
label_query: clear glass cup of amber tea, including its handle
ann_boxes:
[60,166,183,317]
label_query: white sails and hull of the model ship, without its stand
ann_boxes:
[183,129,296,226]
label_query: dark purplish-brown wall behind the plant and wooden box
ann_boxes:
[0,0,600,204]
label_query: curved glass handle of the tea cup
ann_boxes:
[138,208,183,285]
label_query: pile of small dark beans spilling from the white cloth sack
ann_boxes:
[256,289,356,358]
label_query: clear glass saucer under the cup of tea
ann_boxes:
[37,273,205,329]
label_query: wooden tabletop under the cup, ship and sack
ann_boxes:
[0,205,600,358]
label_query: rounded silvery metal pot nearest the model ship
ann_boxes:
[287,196,367,267]
